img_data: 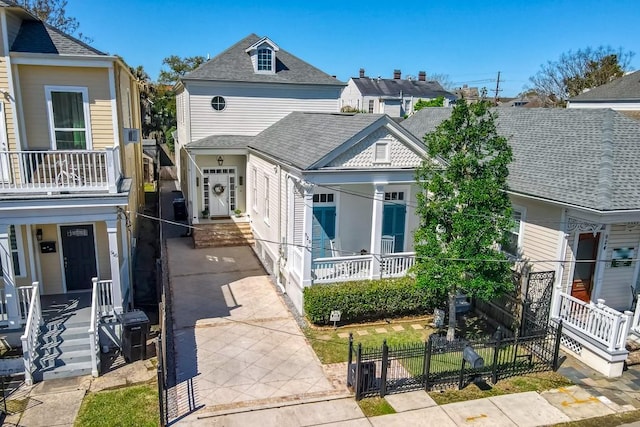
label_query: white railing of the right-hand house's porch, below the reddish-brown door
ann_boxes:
[557,292,631,351]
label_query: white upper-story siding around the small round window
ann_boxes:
[188,82,341,141]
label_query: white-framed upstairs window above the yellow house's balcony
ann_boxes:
[45,86,91,150]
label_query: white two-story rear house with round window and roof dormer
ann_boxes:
[176,34,344,223]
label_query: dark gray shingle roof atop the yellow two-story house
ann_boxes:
[11,21,106,56]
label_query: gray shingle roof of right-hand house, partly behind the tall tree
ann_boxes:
[402,108,640,211]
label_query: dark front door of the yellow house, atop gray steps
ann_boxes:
[60,224,98,292]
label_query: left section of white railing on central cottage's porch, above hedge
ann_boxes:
[312,255,373,283]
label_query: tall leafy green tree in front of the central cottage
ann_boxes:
[414,100,513,339]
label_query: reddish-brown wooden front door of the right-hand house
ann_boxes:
[571,233,600,302]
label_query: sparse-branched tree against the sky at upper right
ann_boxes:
[528,46,634,107]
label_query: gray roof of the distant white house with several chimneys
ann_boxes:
[352,77,456,99]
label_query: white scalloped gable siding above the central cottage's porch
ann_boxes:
[327,128,422,168]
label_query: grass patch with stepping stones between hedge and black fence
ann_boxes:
[304,318,434,364]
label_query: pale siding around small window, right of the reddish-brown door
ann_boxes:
[598,224,640,311]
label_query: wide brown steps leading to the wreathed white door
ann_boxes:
[192,220,255,249]
